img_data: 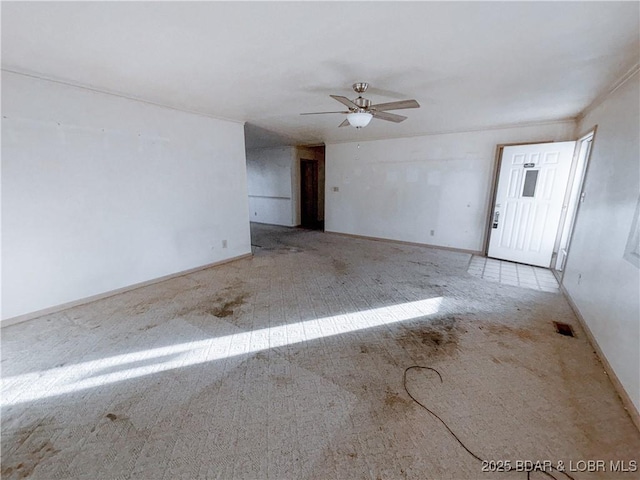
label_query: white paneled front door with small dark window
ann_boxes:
[488,142,576,267]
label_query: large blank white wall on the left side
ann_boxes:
[2,72,251,319]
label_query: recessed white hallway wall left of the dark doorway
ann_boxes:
[247,147,299,227]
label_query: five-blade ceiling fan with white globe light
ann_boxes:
[300,82,420,128]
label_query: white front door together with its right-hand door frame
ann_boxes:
[486,133,596,274]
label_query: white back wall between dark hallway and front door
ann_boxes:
[325,121,575,251]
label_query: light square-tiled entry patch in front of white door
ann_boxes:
[467,255,559,293]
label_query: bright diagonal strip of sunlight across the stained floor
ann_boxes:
[2,297,442,406]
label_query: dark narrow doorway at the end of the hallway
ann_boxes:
[300,146,325,230]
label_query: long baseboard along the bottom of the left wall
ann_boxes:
[0,253,253,328]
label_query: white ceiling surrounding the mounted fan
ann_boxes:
[2,2,640,144]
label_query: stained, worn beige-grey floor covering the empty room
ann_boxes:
[2,225,640,480]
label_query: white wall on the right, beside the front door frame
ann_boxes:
[563,73,640,410]
